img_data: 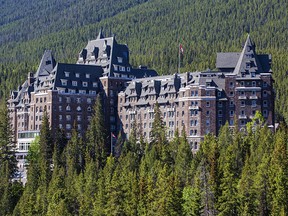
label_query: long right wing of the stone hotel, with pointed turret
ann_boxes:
[118,36,274,151]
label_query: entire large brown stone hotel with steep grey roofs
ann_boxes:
[8,32,274,174]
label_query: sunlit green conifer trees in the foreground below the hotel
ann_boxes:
[0,97,288,216]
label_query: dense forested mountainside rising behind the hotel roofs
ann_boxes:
[0,0,288,121]
